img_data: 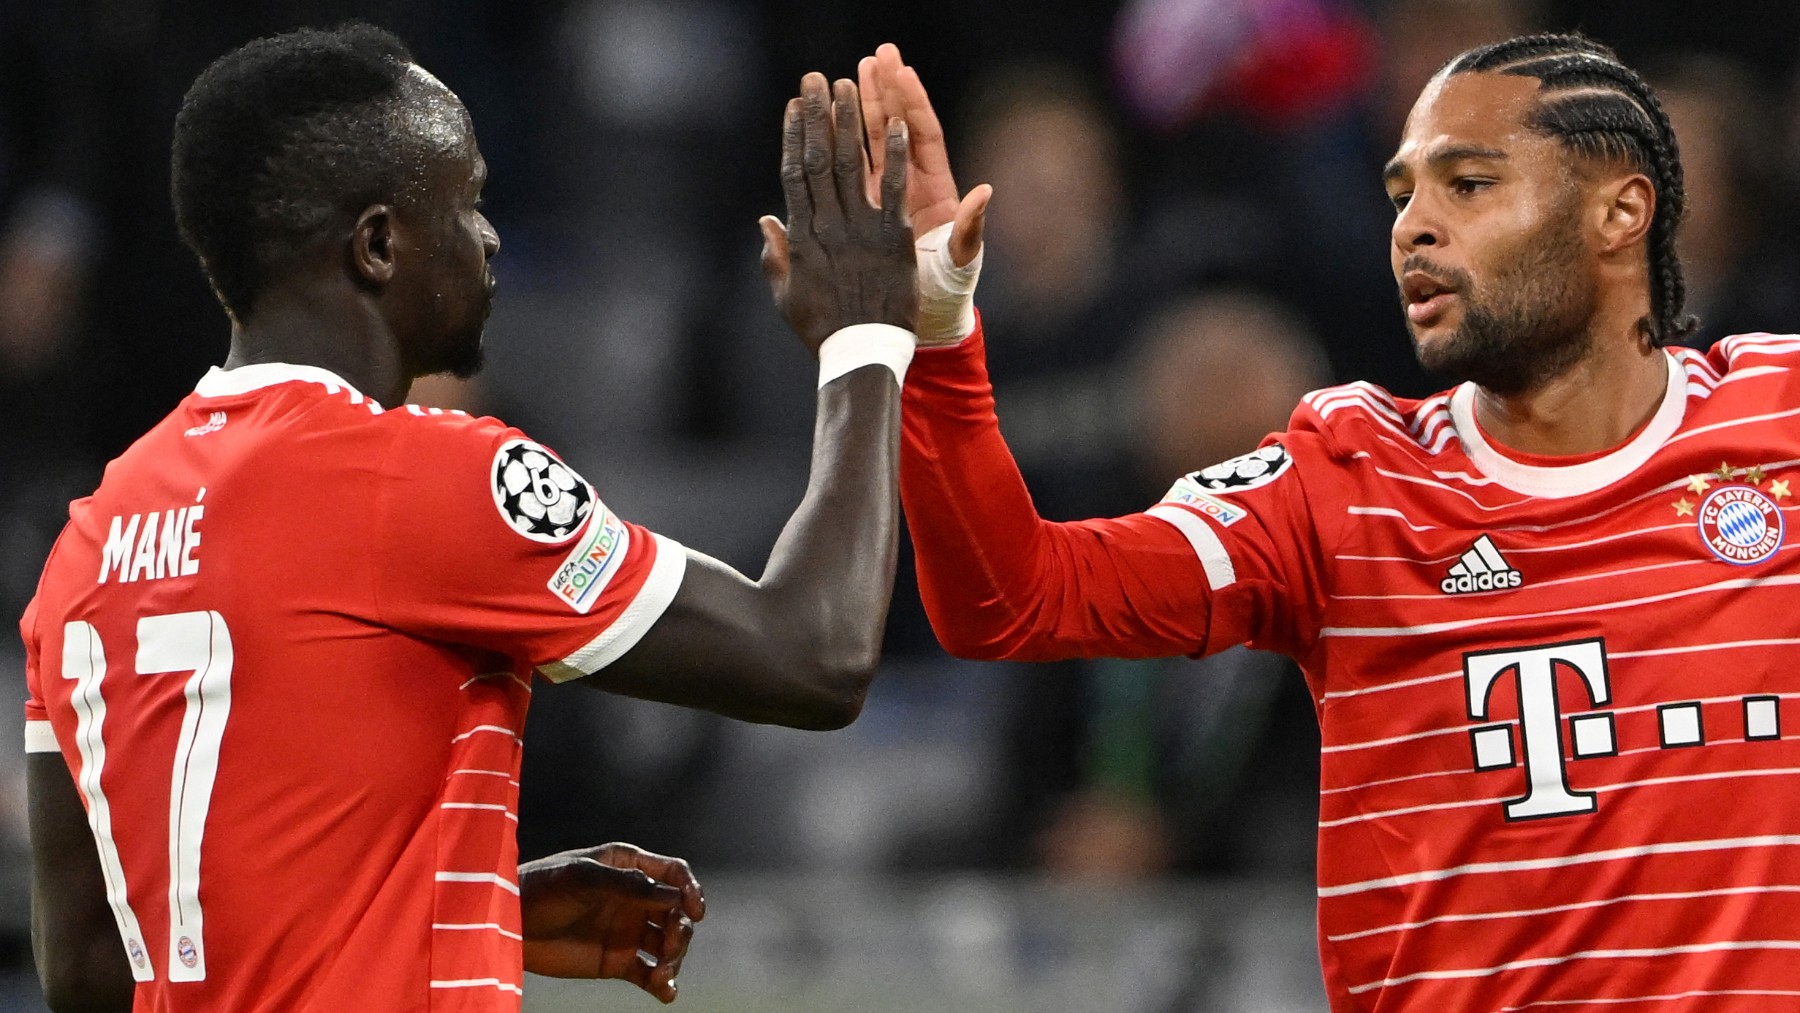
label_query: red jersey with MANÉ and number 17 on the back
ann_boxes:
[23,363,686,1013]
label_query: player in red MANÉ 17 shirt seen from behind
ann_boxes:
[22,25,916,1013]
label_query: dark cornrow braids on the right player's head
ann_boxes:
[1444,34,1699,345]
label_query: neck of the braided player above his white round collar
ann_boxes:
[1474,320,1669,457]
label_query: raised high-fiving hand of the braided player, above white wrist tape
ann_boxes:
[857,43,994,266]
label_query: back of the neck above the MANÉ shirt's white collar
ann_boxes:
[225,279,412,405]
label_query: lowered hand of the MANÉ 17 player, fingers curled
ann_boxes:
[518,844,706,1002]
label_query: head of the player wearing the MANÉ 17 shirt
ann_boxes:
[171,23,499,376]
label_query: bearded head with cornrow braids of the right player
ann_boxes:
[1384,34,1694,394]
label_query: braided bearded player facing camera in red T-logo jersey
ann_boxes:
[862,34,1800,1013]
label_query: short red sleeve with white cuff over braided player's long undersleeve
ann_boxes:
[1145,430,1332,655]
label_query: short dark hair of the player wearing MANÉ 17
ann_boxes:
[169,22,424,318]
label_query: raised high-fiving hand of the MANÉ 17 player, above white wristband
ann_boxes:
[760,74,918,354]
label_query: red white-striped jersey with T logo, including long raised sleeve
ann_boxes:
[902,325,1800,1013]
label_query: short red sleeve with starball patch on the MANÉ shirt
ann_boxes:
[373,412,686,682]
